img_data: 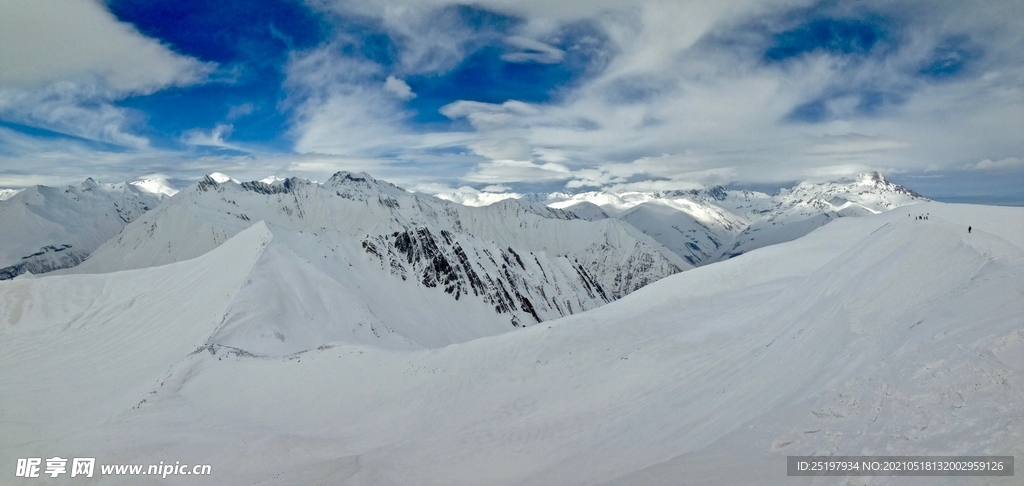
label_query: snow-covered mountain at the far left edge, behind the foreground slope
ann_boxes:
[0,178,166,280]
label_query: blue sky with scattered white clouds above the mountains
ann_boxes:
[0,0,1024,201]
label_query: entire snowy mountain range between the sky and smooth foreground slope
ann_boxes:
[0,172,926,349]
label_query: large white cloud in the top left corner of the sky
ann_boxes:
[0,0,214,148]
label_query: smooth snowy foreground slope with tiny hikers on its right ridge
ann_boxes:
[0,203,1024,485]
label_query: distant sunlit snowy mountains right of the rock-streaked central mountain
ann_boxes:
[439,172,928,266]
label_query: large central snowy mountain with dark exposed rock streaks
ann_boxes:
[66,172,691,349]
